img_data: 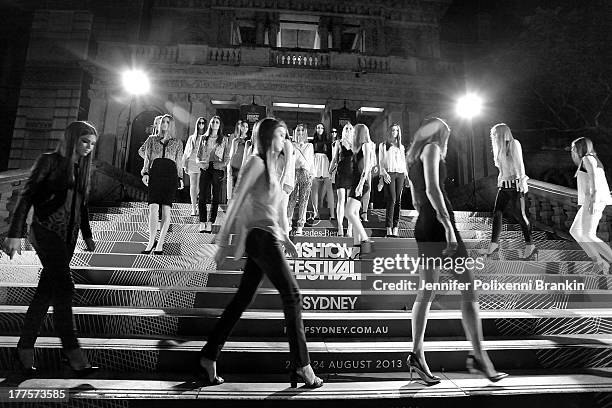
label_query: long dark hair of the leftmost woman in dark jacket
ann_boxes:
[55,121,98,200]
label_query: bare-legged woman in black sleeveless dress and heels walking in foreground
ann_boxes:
[406,118,507,384]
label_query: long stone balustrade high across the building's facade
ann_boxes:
[94,41,454,75]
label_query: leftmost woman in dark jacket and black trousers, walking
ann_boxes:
[4,122,98,375]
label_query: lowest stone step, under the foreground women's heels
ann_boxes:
[1,368,612,408]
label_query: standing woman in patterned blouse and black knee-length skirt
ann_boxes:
[140,115,183,255]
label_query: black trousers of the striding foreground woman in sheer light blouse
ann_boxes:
[201,228,310,368]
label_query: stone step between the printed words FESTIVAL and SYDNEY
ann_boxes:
[0,267,612,294]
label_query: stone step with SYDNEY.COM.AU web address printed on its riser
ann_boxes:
[0,305,612,341]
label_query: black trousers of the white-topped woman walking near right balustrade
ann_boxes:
[491,188,531,244]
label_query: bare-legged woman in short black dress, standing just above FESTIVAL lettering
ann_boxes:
[329,123,354,237]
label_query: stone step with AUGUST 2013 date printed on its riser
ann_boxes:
[0,334,612,372]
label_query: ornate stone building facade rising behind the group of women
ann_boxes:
[9,0,488,201]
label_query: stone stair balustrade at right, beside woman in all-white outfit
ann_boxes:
[527,180,612,242]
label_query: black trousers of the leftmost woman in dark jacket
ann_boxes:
[17,223,79,350]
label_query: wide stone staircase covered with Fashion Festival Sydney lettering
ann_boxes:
[0,203,612,407]
